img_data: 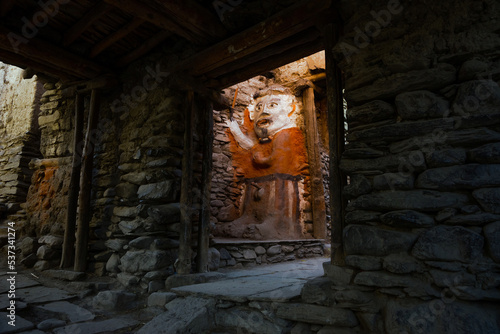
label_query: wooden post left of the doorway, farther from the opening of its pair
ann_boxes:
[177,90,195,275]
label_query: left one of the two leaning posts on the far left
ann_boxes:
[60,94,84,268]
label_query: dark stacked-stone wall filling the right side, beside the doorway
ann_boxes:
[278,0,500,333]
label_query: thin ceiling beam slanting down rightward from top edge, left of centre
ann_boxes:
[104,0,203,44]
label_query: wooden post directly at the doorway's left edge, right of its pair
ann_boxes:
[196,99,214,273]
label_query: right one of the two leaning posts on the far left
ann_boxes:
[74,89,100,271]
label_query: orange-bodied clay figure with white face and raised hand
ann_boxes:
[217,85,308,240]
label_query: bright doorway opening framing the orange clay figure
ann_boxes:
[210,51,331,267]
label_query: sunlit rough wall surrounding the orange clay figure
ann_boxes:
[211,53,330,244]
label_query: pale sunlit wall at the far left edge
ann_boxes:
[0,63,43,220]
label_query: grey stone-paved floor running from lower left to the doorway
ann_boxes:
[0,258,328,334]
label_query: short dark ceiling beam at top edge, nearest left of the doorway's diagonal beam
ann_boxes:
[149,0,227,43]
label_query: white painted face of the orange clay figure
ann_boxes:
[252,94,294,140]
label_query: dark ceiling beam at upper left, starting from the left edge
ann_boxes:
[0,27,108,79]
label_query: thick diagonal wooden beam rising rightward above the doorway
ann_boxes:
[181,0,331,76]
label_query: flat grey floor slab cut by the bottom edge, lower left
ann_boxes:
[54,318,139,334]
